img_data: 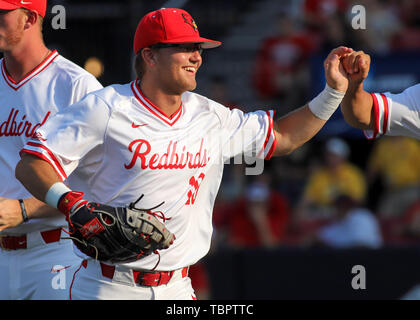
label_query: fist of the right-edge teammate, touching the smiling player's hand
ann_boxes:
[341,51,370,84]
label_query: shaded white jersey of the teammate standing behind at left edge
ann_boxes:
[0,50,102,235]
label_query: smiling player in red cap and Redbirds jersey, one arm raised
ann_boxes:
[16,8,351,300]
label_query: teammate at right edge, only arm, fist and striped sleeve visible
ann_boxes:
[341,51,420,139]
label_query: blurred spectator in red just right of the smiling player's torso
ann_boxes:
[219,172,290,248]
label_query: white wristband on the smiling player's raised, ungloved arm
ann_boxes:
[308,84,345,120]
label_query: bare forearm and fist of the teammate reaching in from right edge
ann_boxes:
[341,51,375,130]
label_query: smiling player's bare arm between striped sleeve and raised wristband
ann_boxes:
[274,105,326,156]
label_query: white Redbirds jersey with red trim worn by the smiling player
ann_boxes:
[22,82,276,271]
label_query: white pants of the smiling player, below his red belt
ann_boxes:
[70,259,196,300]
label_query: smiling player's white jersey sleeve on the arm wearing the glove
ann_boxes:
[20,94,110,181]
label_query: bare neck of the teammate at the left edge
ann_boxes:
[4,41,51,82]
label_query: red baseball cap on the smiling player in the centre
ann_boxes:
[134,8,222,54]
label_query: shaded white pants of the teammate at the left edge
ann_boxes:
[0,232,81,300]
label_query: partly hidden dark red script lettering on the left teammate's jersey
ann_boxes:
[0,108,51,137]
